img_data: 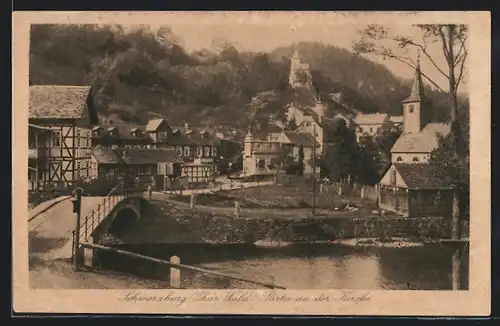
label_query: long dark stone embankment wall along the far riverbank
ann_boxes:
[116,204,468,244]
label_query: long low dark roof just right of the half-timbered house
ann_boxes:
[114,148,183,164]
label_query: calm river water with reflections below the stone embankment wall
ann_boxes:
[98,244,468,290]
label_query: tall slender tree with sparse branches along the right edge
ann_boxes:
[353,24,469,237]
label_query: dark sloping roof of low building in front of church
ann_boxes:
[393,163,452,189]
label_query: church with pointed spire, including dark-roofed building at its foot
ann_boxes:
[378,59,453,217]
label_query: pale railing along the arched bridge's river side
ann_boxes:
[80,183,144,241]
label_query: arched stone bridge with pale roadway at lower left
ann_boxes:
[28,187,145,264]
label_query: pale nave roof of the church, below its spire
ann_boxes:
[391,122,451,153]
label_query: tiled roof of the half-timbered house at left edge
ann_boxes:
[29,85,90,119]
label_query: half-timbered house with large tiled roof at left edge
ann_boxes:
[28,85,97,190]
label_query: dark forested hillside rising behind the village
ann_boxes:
[30,25,456,128]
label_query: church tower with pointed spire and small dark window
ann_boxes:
[402,59,431,133]
